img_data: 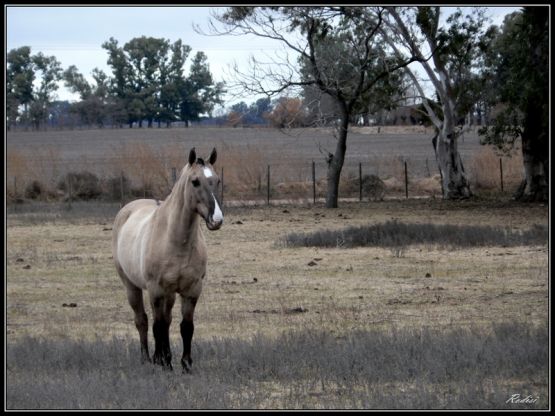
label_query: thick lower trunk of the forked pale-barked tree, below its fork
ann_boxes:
[432,128,472,199]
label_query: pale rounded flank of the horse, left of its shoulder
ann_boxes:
[112,199,158,289]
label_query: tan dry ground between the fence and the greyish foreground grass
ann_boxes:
[6,200,549,343]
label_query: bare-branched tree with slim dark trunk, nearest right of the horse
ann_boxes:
[201,7,417,208]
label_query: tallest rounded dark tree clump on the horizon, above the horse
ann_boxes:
[102,36,223,127]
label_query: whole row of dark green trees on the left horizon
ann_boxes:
[6,36,224,129]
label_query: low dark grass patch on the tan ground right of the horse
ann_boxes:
[278,221,548,248]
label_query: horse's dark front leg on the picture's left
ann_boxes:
[150,293,175,370]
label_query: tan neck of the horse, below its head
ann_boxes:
[160,178,199,246]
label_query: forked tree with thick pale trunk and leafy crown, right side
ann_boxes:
[382,6,490,199]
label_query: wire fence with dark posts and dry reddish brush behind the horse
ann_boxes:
[7,156,518,206]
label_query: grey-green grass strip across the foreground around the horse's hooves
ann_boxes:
[6,323,549,410]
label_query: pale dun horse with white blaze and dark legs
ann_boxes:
[112,148,224,373]
